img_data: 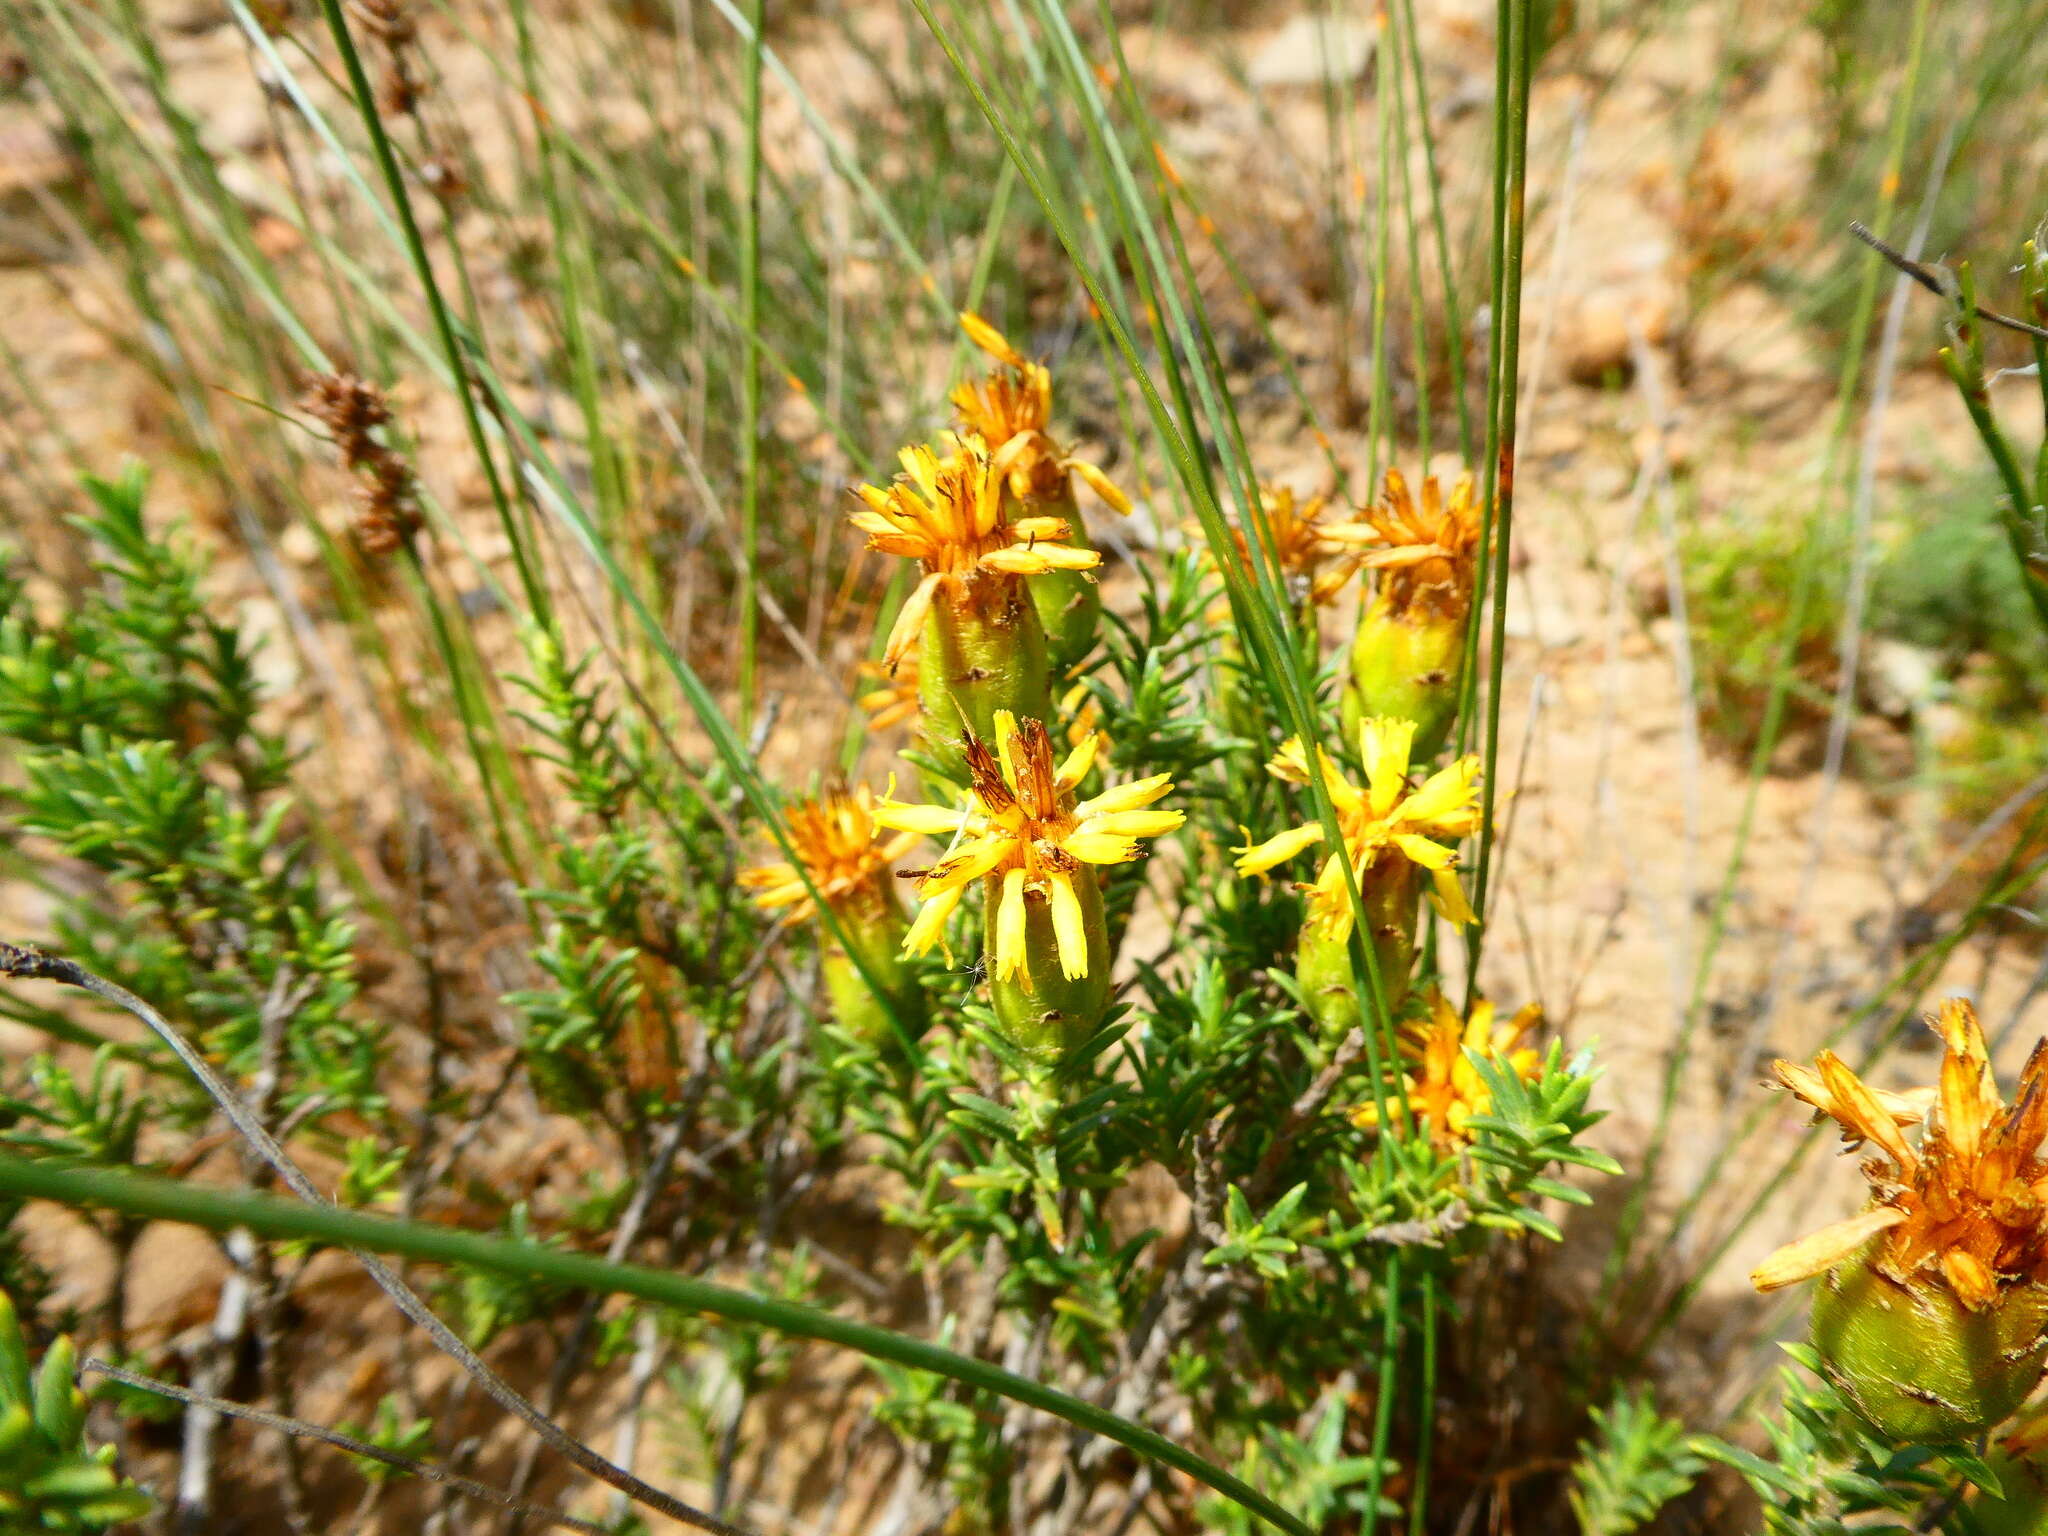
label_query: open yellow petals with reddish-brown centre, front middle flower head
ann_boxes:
[874,711,1186,981]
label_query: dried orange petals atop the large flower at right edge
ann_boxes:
[1749,997,2048,1313]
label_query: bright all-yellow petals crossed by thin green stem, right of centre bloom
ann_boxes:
[1233,717,1479,938]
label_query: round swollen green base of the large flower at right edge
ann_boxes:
[1812,1237,2048,1446]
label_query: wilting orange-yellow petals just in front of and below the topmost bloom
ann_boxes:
[850,438,1102,666]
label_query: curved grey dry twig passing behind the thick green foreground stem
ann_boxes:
[0,944,745,1536]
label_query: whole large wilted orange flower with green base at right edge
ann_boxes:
[1749,997,2048,1444]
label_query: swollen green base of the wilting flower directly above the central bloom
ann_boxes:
[918,573,1053,782]
